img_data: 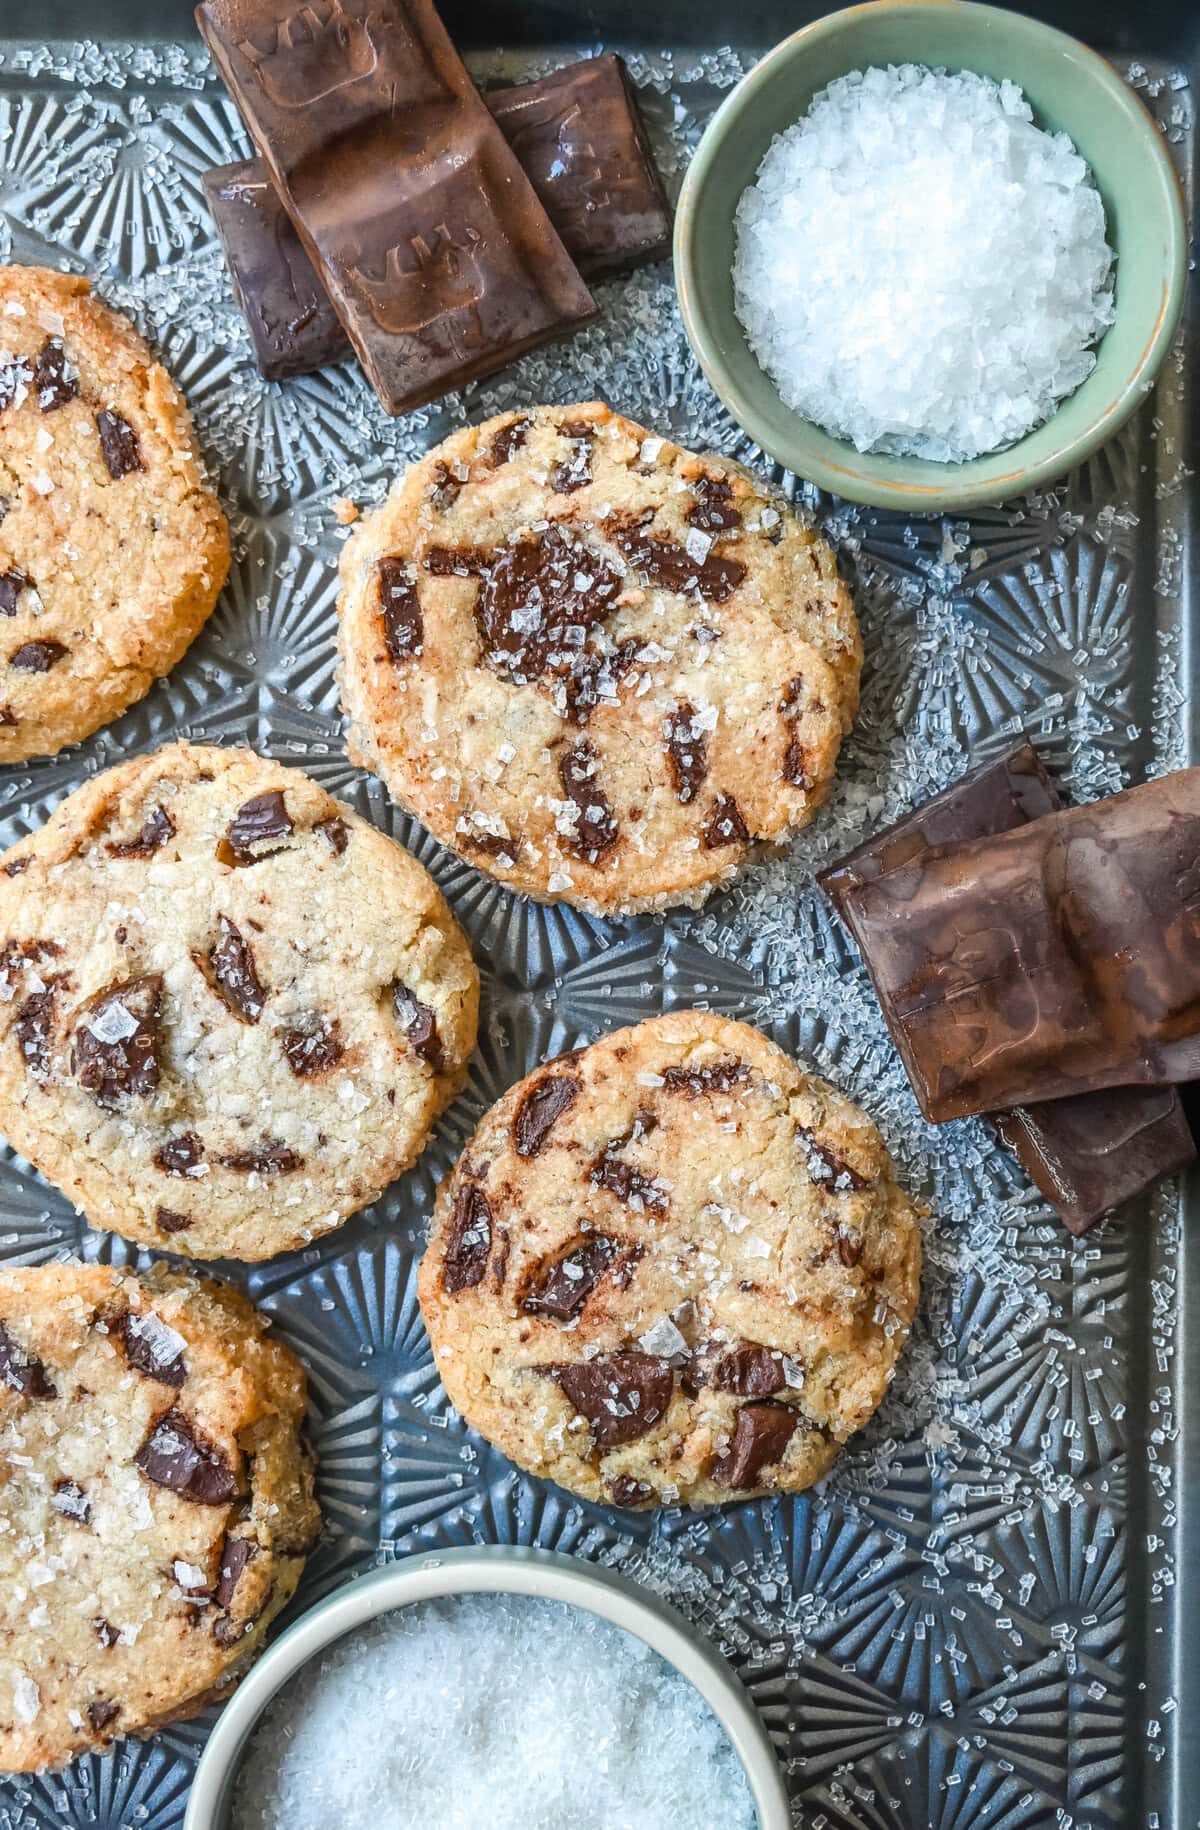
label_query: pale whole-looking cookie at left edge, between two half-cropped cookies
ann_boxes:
[0,743,479,1259]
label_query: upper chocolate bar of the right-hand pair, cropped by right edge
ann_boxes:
[819,769,1200,1124]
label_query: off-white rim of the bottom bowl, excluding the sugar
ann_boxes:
[183,1545,792,1830]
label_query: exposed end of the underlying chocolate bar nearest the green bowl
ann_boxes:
[485,51,671,278]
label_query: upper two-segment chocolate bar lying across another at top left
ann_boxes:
[196,0,596,414]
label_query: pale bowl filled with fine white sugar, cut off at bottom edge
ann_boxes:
[185,1546,790,1830]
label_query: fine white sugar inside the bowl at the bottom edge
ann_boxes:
[232,1596,757,1830]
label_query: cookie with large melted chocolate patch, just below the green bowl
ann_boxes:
[338,403,862,913]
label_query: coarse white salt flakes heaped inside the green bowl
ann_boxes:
[734,64,1114,463]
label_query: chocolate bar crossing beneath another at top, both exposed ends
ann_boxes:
[205,53,671,381]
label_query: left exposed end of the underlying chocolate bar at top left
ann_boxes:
[205,159,349,381]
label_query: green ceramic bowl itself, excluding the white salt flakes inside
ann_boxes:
[673,0,1189,514]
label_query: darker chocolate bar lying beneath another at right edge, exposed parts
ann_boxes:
[821,743,1196,1233]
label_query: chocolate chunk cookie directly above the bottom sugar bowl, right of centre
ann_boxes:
[419,1010,920,1506]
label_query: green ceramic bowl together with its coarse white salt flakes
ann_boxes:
[675,0,1187,512]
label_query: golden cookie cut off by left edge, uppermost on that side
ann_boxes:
[0,267,229,763]
